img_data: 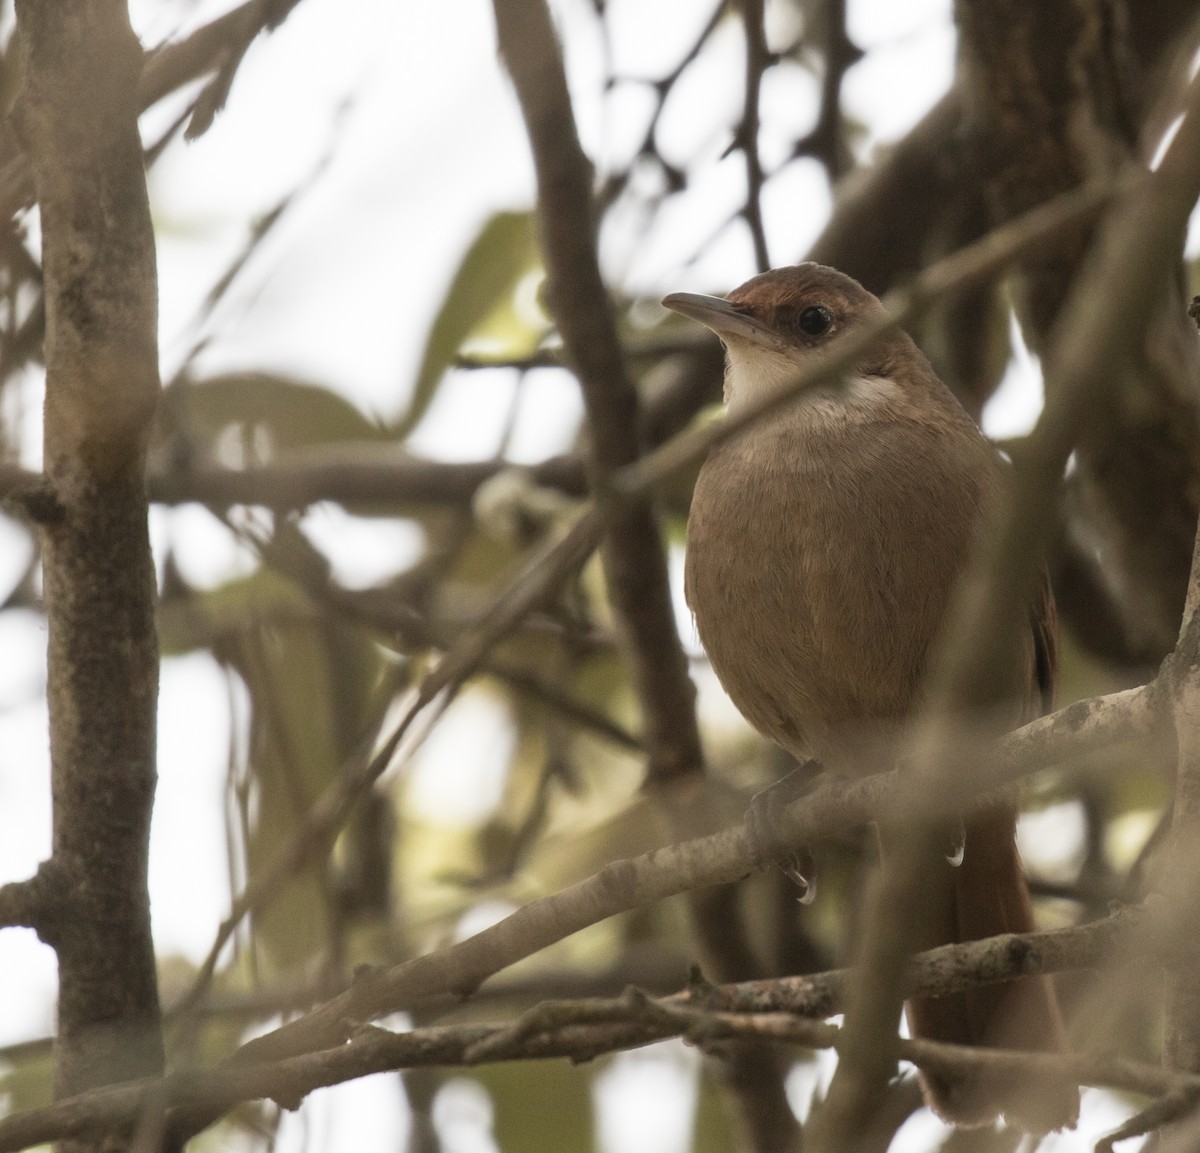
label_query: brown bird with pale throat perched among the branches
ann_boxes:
[664,264,1079,1131]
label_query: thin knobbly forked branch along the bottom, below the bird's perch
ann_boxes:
[0,911,1161,1153]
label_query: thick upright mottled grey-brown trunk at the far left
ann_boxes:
[14,0,163,1095]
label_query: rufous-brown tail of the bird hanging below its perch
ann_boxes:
[902,806,1079,1133]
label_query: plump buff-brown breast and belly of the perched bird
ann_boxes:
[685,406,994,764]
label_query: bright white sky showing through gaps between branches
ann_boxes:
[0,0,1195,1153]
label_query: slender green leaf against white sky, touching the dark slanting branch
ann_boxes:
[392,212,538,438]
